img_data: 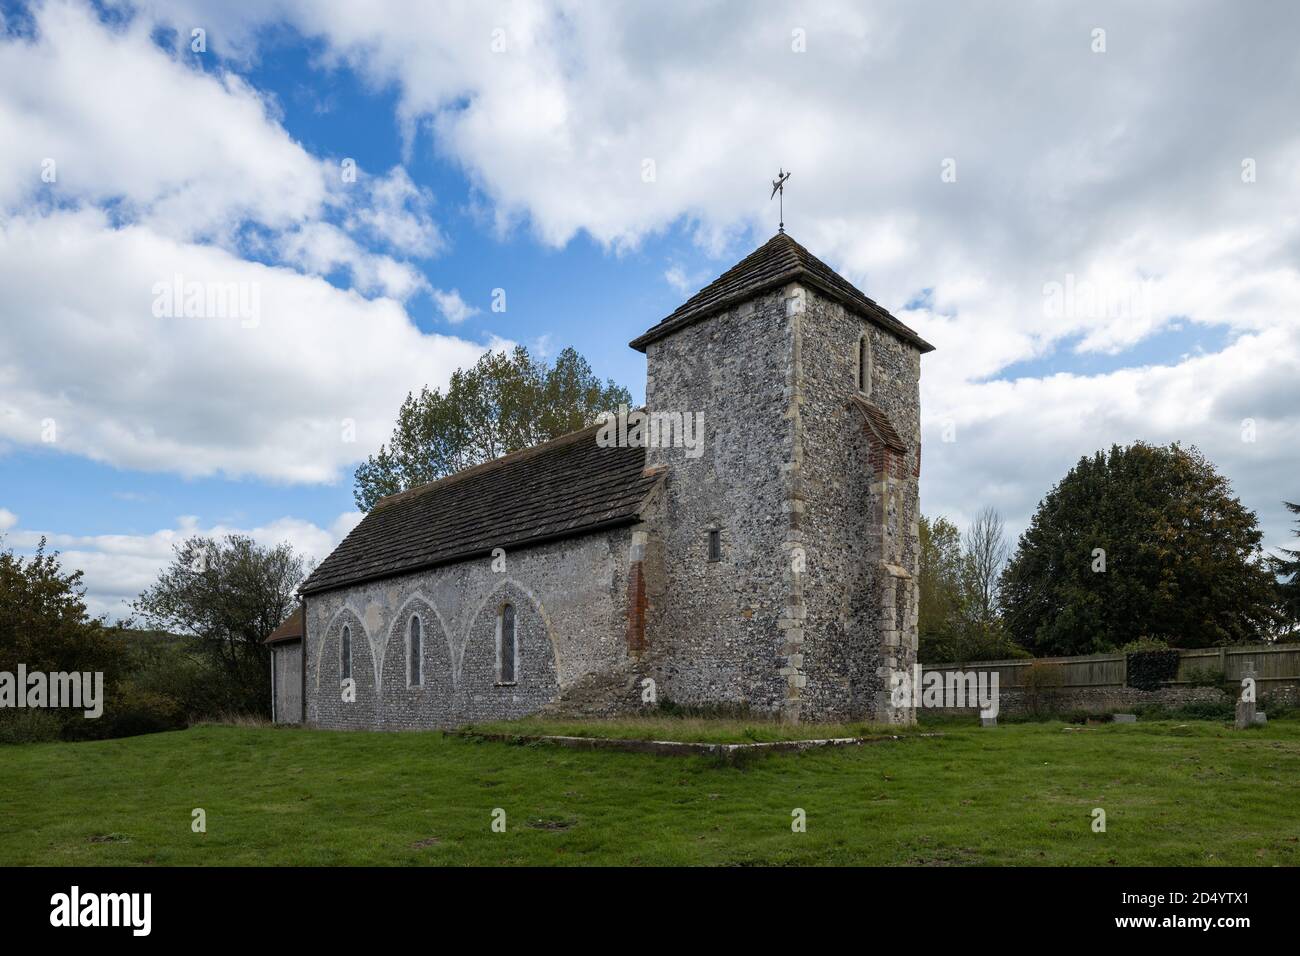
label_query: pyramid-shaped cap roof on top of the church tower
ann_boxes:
[631,233,935,352]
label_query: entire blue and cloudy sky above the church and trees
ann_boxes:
[0,0,1300,617]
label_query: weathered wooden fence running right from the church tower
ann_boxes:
[922,644,1300,691]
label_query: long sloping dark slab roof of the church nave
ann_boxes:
[302,425,659,593]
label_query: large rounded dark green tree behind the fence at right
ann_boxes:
[1001,442,1275,656]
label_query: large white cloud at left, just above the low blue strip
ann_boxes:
[0,211,485,481]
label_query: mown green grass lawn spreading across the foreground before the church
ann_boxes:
[0,721,1300,866]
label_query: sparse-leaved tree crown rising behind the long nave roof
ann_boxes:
[352,346,632,511]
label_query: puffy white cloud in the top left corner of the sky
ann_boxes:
[0,0,328,239]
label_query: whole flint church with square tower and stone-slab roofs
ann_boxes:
[272,229,931,730]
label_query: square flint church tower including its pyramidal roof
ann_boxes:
[632,233,931,722]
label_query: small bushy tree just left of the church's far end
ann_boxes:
[134,535,303,714]
